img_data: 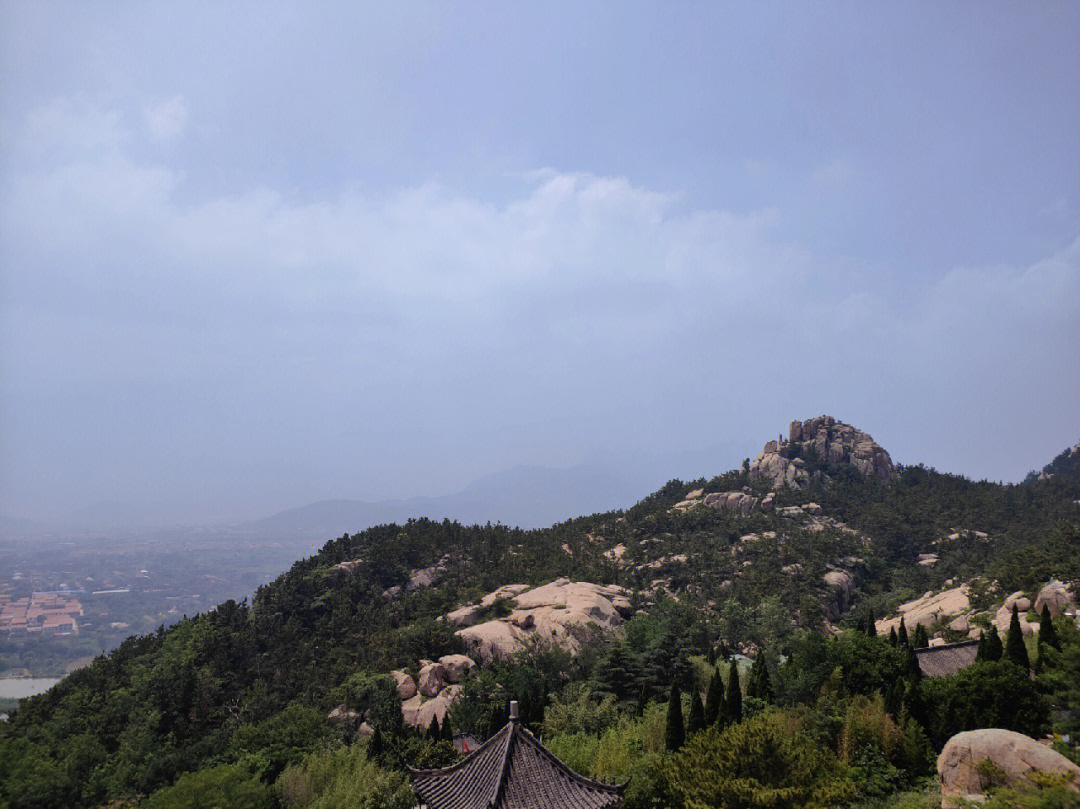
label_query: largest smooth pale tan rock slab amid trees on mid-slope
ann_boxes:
[457,579,631,663]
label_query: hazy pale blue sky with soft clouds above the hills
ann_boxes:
[0,1,1080,522]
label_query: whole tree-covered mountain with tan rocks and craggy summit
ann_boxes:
[0,416,1080,809]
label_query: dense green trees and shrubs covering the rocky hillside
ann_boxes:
[0,442,1080,809]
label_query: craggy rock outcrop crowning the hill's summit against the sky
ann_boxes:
[750,416,896,488]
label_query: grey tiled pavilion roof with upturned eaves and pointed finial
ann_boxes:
[413,705,622,809]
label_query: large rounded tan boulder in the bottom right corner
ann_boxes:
[937,728,1080,808]
